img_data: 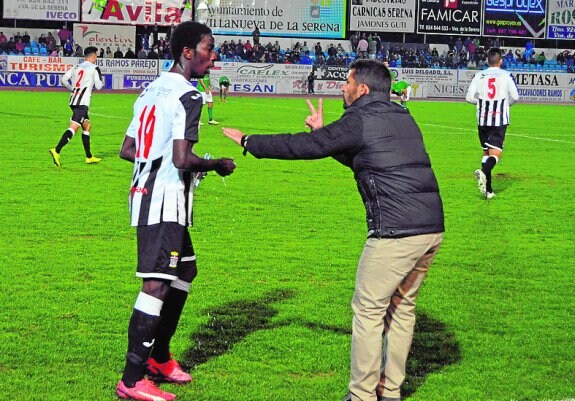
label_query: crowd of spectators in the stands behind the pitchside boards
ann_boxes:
[0,25,575,72]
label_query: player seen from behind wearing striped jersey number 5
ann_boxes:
[465,48,519,199]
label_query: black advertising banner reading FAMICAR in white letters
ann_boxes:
[417,0,481,36]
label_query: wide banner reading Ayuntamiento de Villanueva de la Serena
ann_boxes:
[196,0,348,38]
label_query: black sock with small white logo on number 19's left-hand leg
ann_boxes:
[122,309,160,387]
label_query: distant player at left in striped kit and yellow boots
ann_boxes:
[50,46,104,167]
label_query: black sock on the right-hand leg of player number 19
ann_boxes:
[151,287,188,363]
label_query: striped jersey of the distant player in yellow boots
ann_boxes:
[62,61,104,107]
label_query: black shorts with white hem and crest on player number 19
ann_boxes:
[136,223,196,282]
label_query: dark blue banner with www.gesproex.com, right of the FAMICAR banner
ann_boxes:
[483,0,548,39]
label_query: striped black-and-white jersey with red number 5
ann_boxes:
[465,67,519,127]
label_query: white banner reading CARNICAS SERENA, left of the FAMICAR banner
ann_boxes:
[349,0,415,33]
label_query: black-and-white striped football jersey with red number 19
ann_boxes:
[126,72,202,226]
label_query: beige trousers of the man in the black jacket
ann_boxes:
[349,233,443,401]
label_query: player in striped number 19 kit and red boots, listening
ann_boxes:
[116,21,235,401]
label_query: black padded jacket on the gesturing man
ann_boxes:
[246,92,444,238]
